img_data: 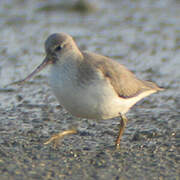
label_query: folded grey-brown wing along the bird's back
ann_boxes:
[84,52,160,98]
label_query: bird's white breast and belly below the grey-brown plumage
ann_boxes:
[50,66,155,119]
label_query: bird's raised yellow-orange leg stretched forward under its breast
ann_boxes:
[44,129,77,148]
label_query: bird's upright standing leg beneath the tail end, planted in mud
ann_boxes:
[116,114,128,147]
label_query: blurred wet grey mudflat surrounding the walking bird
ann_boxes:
[0,0,180,180]
